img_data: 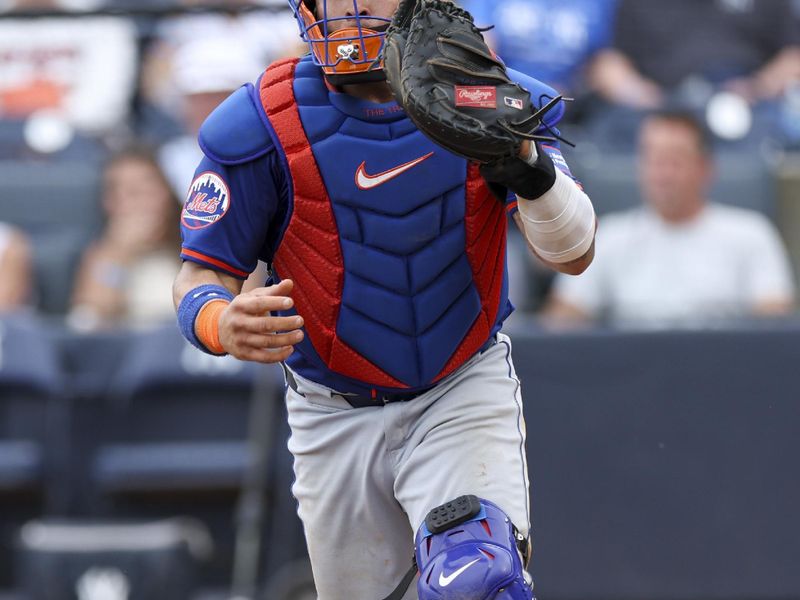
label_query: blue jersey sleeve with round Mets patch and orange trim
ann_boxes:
[181,151,288,279]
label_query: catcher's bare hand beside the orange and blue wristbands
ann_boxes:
[219,279,304,364]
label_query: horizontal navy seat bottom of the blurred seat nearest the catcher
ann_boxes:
[93,441,249,492]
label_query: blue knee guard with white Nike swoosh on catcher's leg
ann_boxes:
[416,496,533,600]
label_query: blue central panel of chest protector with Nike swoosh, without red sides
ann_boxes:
[294,62,488,388]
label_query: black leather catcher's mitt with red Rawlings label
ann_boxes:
[384,0,561,163]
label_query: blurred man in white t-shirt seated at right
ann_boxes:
[545,112,794,327]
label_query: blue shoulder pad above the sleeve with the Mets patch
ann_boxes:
[198,83,275,165]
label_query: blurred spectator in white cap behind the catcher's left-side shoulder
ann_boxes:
[158,37,265,199]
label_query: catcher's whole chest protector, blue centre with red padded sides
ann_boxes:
[201,58,560,393]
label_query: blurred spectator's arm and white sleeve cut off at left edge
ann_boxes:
[0,223,33,312]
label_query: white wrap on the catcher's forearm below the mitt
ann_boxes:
[518,168,596,264]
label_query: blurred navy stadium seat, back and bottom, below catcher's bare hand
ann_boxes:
[93,325,268,494]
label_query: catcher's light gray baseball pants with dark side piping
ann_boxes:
[287,334,530,600]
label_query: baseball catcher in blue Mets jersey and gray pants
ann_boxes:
[175,0,595,600]
